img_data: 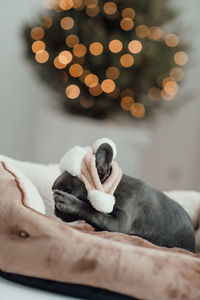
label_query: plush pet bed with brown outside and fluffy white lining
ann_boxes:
[0,156,200,300]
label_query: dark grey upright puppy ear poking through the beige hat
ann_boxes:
[95,143,113,183]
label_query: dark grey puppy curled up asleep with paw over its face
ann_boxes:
[52,139,195,252]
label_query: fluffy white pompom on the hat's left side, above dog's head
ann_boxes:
[59,146,87,176]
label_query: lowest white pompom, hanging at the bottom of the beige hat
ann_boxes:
[88,190,115,214]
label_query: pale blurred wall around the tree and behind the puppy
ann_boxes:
[0,0,200,189]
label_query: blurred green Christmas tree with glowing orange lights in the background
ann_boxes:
[25,0,188,118]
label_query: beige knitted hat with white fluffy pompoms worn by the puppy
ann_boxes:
[59,138,122,213]
